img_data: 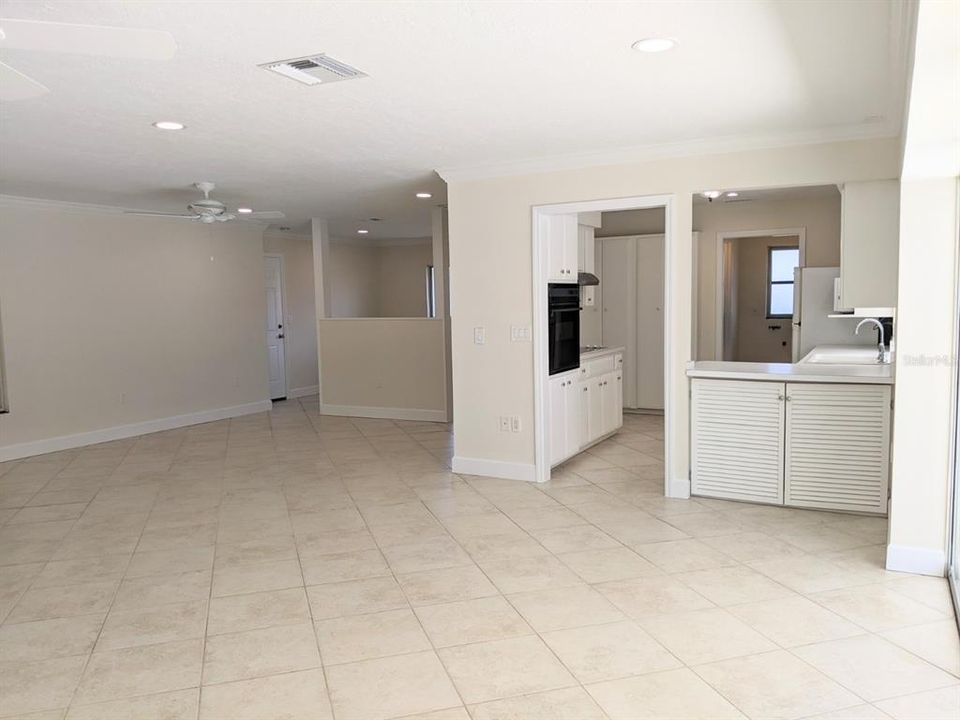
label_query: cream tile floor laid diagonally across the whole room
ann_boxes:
[0,399,960,720]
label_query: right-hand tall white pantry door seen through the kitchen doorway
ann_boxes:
[624,235,664,410]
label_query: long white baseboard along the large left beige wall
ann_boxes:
[0,400,271,462]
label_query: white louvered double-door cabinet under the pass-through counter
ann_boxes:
[690,378,891,514]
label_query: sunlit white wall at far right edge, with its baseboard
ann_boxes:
[887,0,960,575]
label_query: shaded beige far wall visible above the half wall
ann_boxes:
[327,238,433,318]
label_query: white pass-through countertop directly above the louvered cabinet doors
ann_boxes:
[687,360,893,385]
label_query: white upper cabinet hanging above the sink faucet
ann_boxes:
[840,180,900,314]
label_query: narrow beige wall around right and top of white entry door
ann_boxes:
[263,232,317,397]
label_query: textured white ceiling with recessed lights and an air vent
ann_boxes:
[0,0,904,237]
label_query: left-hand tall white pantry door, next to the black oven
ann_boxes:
[601,237,636,408]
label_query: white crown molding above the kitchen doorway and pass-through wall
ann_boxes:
[436,118,900,183]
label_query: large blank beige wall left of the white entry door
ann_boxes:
[0,205,267,459]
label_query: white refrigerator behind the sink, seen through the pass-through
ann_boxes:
[792,267,877,362]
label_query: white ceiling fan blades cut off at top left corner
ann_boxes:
[0,18,177,101]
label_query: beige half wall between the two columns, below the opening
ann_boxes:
[319,318,446,421]
